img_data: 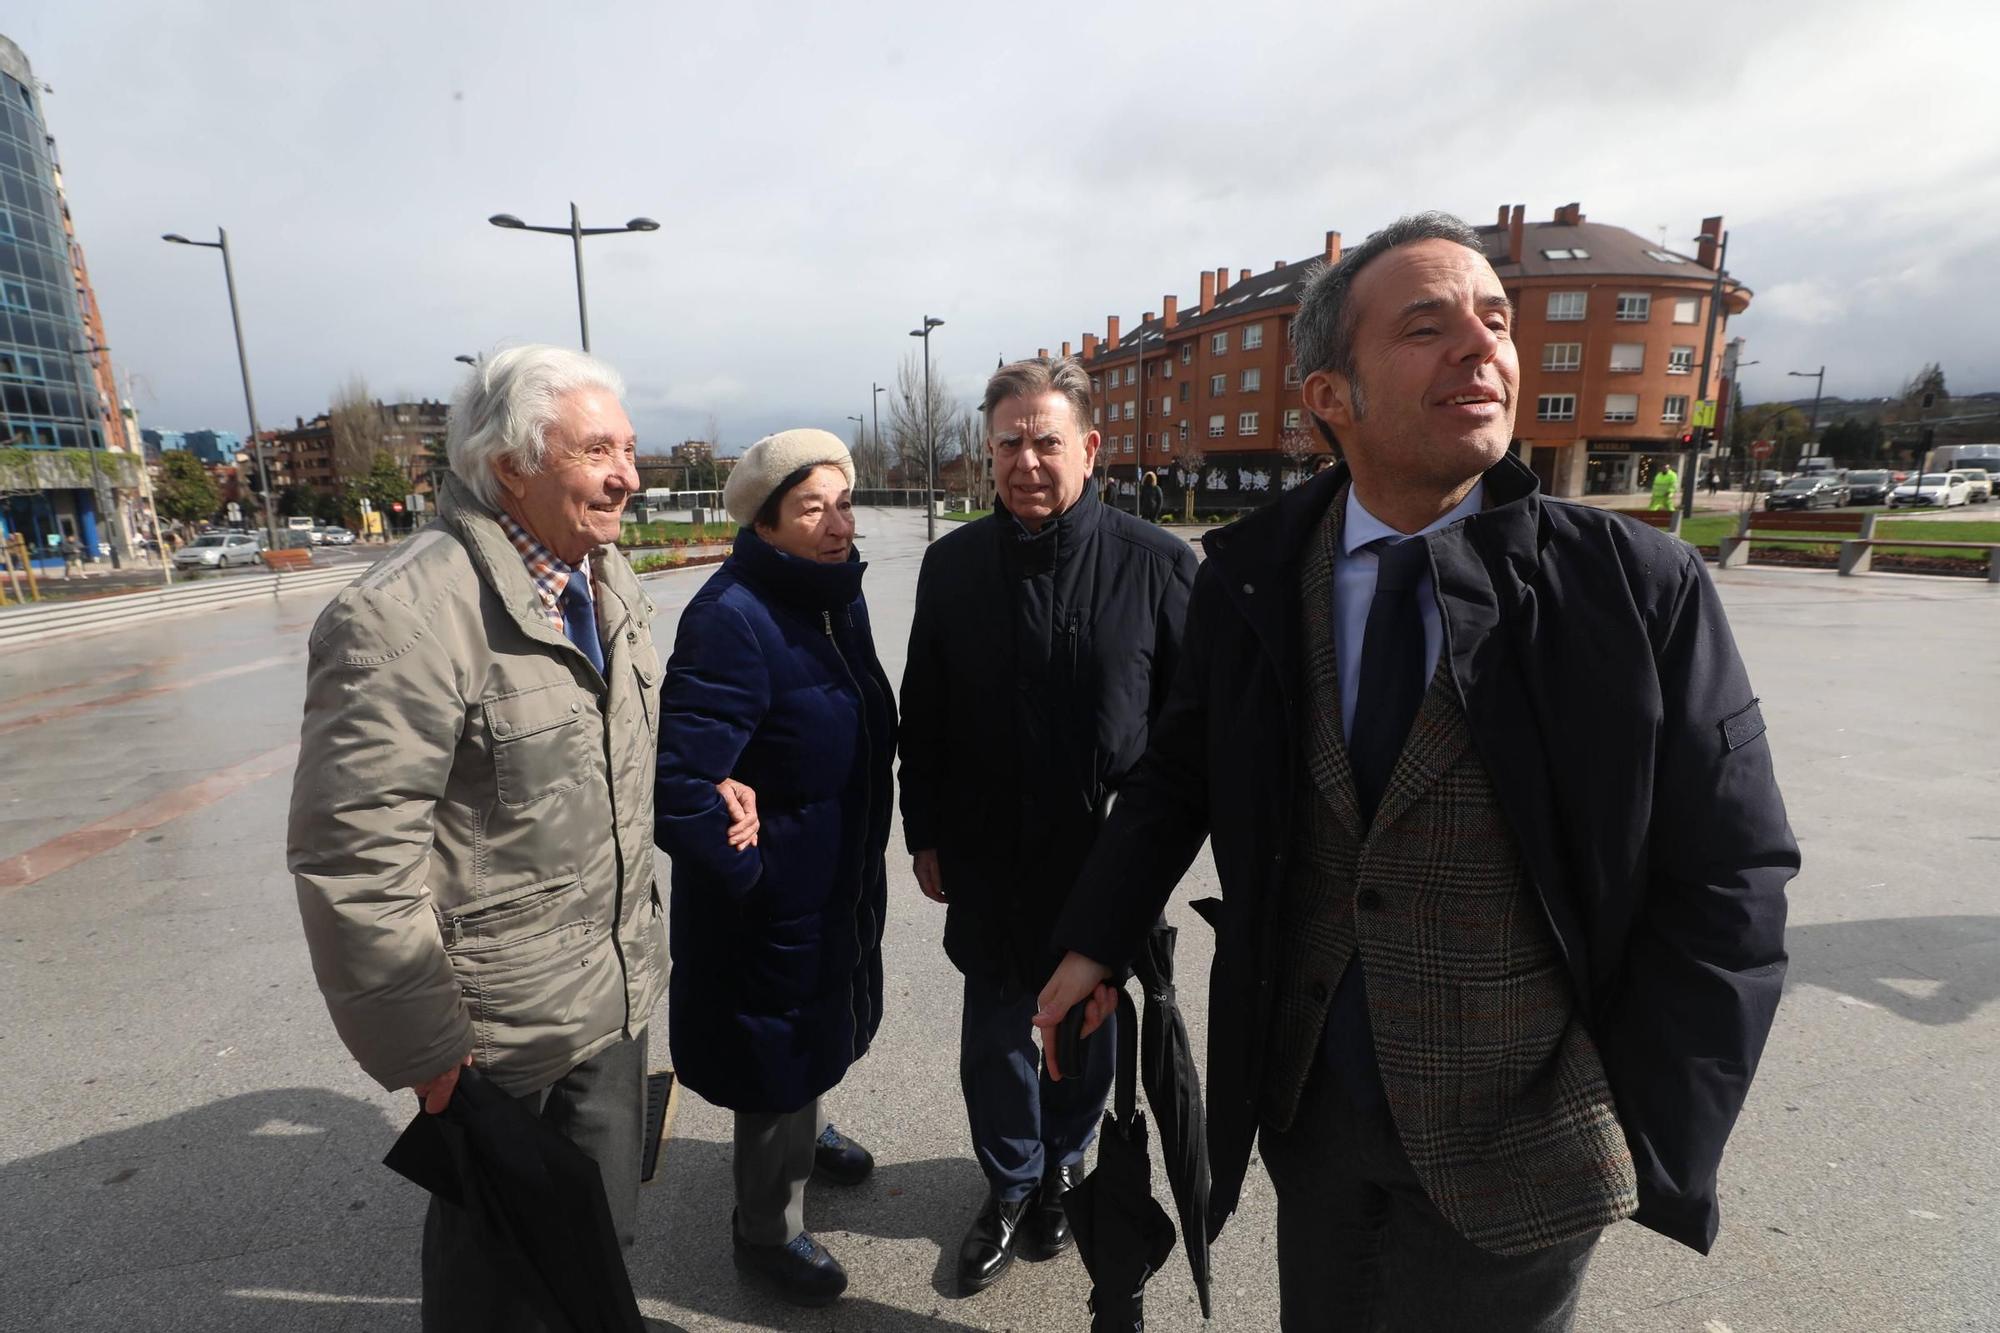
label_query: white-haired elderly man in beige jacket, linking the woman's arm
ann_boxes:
[290,346,754,1331]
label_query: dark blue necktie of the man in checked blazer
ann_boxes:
[1324,536,1430,1111]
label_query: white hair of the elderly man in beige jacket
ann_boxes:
[444,342,624,508]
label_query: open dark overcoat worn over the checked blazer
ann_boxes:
[1056,456,1798,1253]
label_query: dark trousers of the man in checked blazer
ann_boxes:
[1260,1063,1600,1333]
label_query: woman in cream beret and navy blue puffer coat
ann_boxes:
[654,430,896,1305]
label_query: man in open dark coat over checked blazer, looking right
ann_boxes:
[1036,214,1798,1331]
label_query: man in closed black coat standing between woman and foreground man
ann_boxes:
[900,358,1194,1293]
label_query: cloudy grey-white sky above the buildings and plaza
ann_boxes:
[0,0,2000,448]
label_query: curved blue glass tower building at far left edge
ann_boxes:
[0,36,126,558]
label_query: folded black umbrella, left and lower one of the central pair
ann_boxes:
[1062,987,1174,1333]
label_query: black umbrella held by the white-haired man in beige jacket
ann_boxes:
[382,1067,646,1333]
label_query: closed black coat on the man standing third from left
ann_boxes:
[900,484,1196,991]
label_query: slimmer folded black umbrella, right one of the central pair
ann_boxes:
[1132,921,1212,1319]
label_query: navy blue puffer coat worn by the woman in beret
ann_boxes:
[654,528,896,1111]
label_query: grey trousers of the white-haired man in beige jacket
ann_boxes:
[424,1033,646,1333]
